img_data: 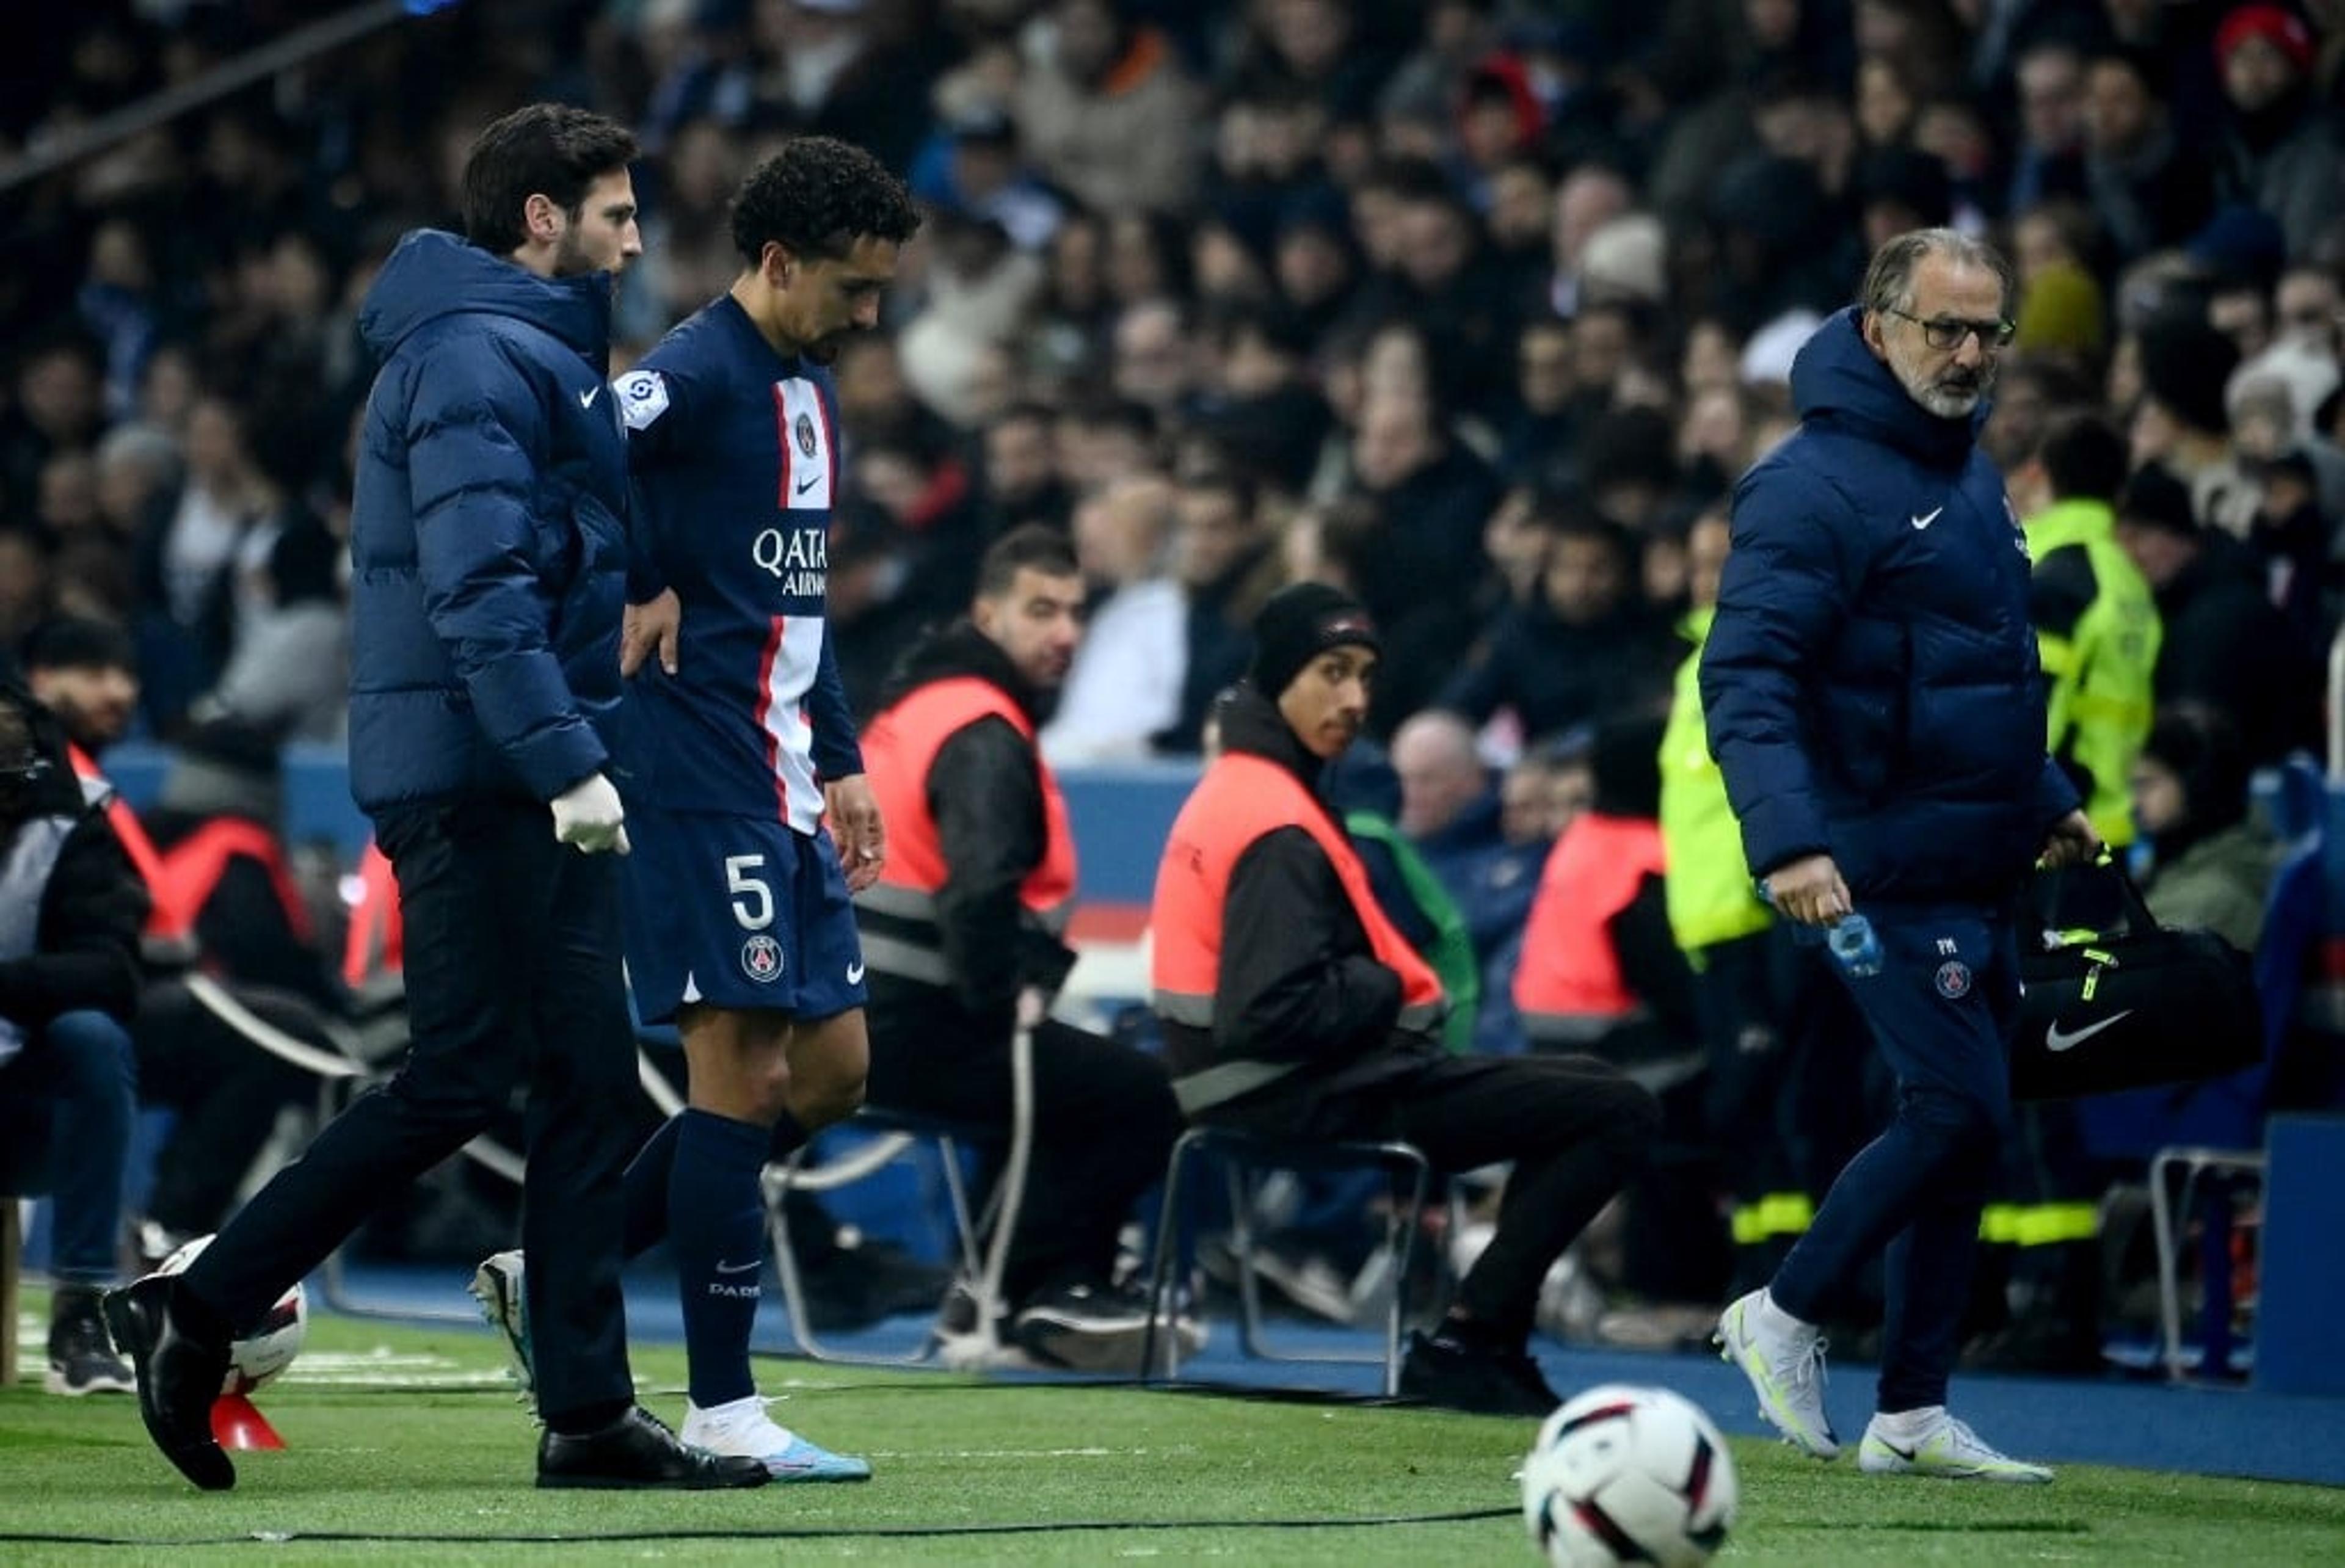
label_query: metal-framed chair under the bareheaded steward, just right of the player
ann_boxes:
[765,1029,1034,1369]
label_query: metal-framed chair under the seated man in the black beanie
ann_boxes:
[1140,1125,1433,1397]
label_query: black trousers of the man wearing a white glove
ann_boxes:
[185,802,640,1428]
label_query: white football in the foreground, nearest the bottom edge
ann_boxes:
[1522,1383,1740,1568]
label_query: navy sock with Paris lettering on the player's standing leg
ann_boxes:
[668,1111,767,1411]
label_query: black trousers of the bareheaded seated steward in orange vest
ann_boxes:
[865,1007,1182,1305]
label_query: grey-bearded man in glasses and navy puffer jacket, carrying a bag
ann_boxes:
[1703,230,2099,1481]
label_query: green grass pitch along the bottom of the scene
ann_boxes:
[0,1303,2345,1568]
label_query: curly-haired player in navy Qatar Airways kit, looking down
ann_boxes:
[474,136,919,1481]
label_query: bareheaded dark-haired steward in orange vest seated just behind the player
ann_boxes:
[856,525,1180,1371]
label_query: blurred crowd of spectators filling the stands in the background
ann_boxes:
[0,0,2345,1396]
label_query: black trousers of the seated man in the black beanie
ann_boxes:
[1201,1057,1660,1334]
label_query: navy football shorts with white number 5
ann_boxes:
[619,811,865,1024]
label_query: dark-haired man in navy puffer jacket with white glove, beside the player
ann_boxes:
[106,103,767,1490]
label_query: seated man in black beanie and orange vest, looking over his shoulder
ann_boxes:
[1149,584,1660,1415]
